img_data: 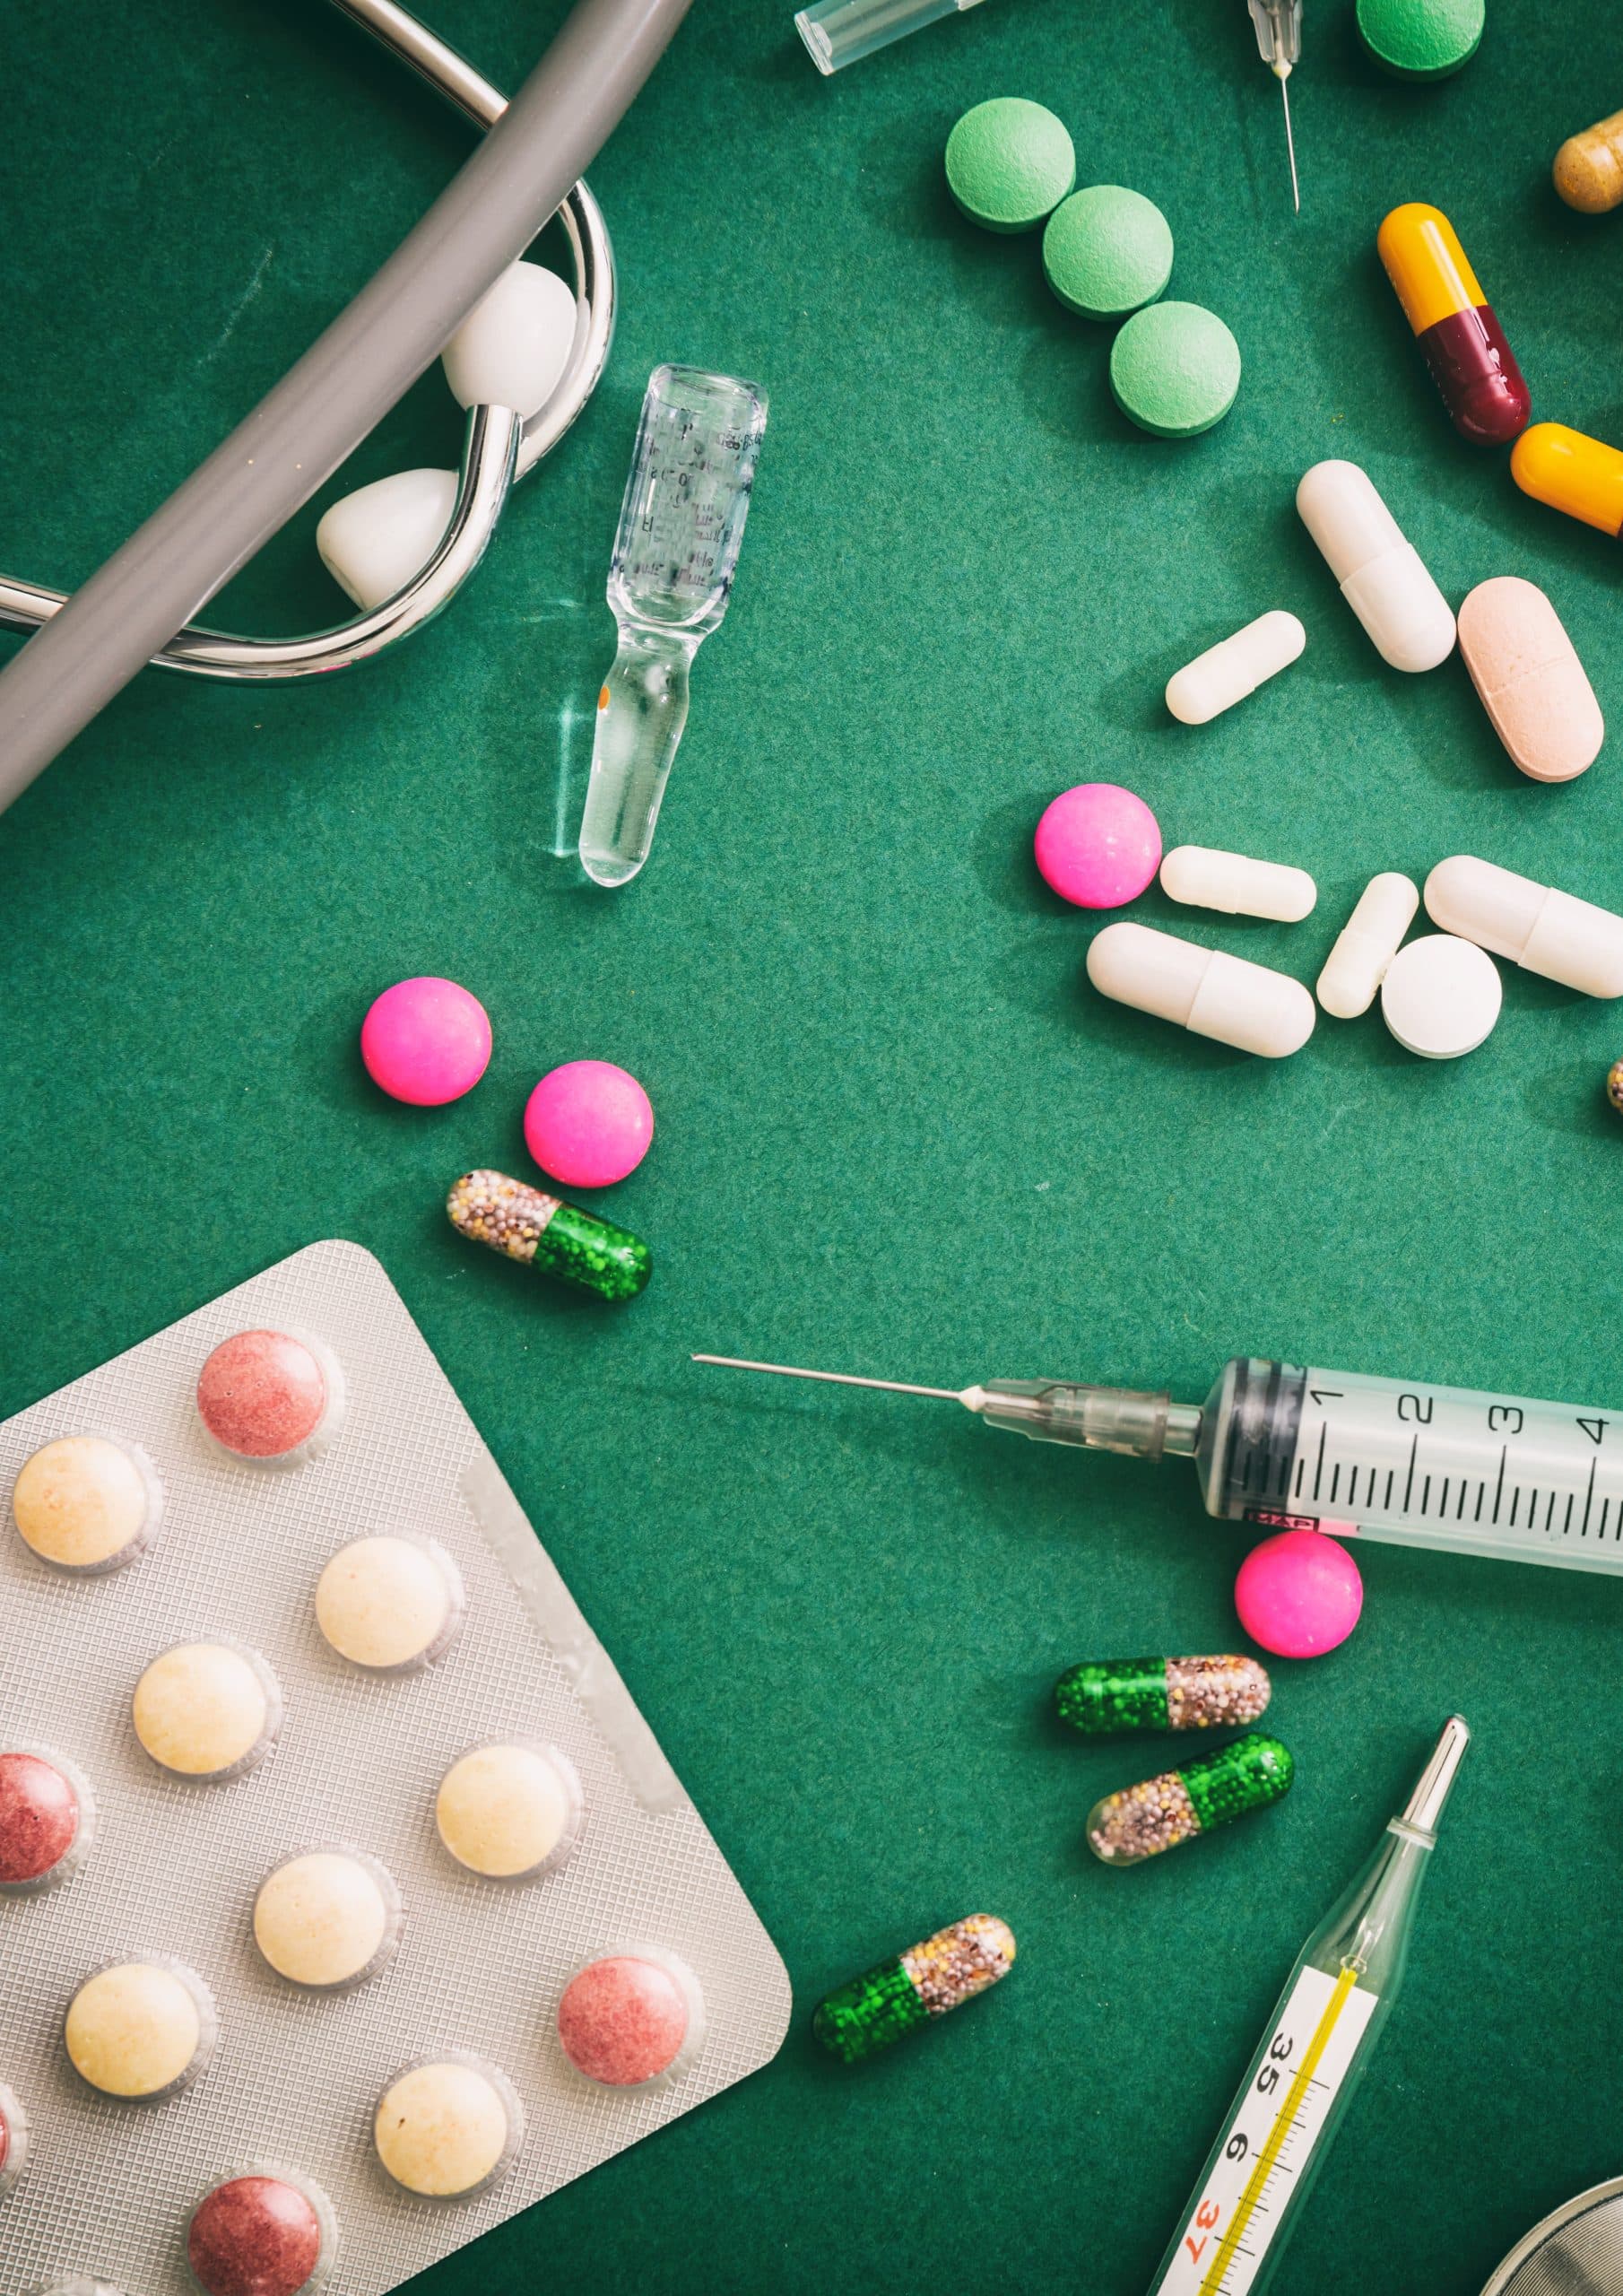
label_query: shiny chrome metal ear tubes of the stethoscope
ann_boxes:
[0,0,615,682]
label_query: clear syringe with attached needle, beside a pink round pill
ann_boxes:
[693,1354,1623,1573]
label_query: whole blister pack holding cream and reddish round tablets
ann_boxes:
[0,1242,790,2296]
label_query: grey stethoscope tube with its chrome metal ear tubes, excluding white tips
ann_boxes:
[0,0,689,811]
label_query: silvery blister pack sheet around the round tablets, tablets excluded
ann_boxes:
[0,1242,790,2296]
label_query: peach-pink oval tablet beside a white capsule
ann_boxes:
[1460,574,1607,780]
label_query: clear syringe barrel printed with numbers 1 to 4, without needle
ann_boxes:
[1196,1357,1623,1573]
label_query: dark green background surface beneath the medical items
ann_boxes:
[0,0,1623,2296]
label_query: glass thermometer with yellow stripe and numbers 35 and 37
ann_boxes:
[1150,1715,1471,2296]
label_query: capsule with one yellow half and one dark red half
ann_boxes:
[1376,200,1533,446]
